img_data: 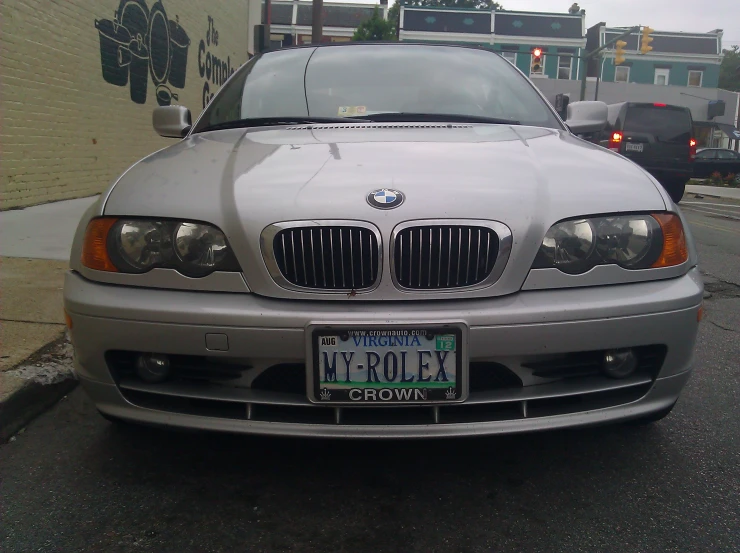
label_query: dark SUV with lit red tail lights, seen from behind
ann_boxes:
[600,102,696,203]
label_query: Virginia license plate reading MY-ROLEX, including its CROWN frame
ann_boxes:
[308,325,467,405]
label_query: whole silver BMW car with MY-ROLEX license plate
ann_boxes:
[64,43,703,438]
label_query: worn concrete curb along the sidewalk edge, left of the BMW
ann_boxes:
[0,337,78,443]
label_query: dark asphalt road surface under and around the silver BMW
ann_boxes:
[0,195,740,553]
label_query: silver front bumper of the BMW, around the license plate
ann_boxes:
[65,269,703,438]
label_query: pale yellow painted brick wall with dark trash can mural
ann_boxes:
[0,0,254,209]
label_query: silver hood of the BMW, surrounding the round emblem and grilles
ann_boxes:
[103,124,666,299]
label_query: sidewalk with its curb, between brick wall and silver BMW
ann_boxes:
[0,194,96,442]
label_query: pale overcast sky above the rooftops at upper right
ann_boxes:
[340,0,740,48]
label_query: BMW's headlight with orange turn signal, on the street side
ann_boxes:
[532,213,688,274]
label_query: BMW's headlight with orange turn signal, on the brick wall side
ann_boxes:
[82,217,241,277]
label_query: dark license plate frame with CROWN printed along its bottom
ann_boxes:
[306,321,469,407]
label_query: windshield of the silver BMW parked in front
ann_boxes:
[195,45,562,132]
